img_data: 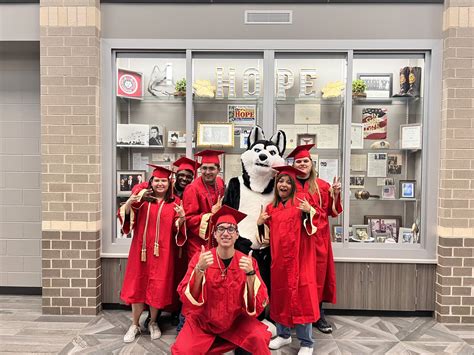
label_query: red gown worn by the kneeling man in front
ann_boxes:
[171,248,271,355]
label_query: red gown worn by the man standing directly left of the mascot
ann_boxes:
[183,177,225,260]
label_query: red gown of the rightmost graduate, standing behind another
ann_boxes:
[296,178,342,303]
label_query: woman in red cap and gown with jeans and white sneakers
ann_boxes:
[257,166,319,354]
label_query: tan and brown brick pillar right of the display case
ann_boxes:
[436,0,474,323]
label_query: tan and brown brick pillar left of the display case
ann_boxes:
[40,0,101,315]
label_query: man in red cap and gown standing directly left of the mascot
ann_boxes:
[183,149,225,260]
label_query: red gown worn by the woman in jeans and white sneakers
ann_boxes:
[266,201,319,327]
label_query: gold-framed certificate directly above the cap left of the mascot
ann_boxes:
[197,122,234,147]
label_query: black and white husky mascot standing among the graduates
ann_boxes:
[223,126,286,292]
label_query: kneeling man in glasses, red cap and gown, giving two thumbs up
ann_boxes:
[171,206,271,355]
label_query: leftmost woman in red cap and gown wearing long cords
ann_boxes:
[117,164,186,343]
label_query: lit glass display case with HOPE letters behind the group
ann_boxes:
[102,40,440,263]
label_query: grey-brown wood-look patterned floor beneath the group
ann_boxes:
[0,296,474,355]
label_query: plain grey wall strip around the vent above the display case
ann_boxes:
[101,4,443,39]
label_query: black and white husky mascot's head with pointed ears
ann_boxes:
[241,126,286,193]
